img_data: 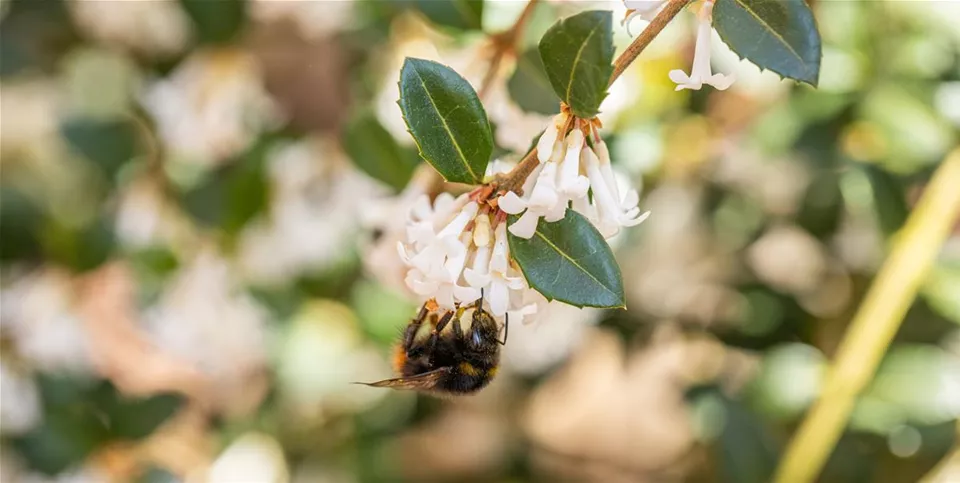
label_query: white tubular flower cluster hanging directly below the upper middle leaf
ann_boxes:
[498,113,649,242]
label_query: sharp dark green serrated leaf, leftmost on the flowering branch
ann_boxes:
[400,58,493,184]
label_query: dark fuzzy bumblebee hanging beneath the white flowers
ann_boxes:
[360,296,509,396]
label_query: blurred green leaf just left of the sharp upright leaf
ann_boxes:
[343,112,420,191]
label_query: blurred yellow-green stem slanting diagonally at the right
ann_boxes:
[774,149,960,483]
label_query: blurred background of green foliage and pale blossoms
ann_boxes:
[0,0,960,483]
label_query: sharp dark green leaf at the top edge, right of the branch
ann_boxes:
[713,0,821,87]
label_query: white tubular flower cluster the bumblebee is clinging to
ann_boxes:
[397,193,537,321]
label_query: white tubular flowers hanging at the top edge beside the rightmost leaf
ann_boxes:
[621,0,735,91]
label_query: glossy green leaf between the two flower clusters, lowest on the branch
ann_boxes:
[508,210,626,308]
